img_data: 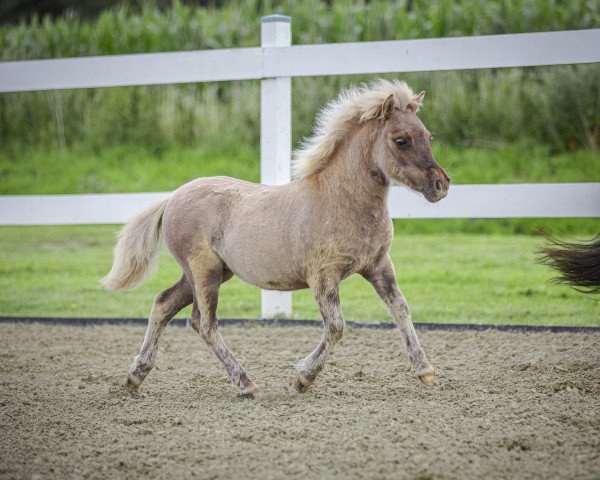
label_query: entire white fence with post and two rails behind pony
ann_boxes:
[0,15,600,318]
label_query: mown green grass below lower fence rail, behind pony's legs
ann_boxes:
[0,226,600,325]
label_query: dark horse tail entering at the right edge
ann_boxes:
[538,233,600,293]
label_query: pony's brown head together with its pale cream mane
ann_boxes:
[293,80,450,202]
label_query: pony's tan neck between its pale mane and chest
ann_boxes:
[314,122,389,217]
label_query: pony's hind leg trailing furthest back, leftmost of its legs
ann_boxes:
[127,275,193,388]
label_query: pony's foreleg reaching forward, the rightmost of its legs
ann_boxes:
[361,255,435,385]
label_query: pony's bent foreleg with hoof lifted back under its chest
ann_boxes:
[292,281,344,392]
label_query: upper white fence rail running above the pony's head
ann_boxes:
[0,28,600,92]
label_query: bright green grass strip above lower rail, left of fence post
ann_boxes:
[0,145,260,195]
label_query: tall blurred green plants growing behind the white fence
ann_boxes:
[0,0,600,151]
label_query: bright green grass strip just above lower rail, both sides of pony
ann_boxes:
[0,139,600,195]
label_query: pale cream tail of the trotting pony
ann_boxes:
[100,200,167,292]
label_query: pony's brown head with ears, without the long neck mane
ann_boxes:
[373,92,450,202]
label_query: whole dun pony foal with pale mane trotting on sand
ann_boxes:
[103,80,450,396]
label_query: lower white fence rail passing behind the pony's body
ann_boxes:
[0,183,600,225]
